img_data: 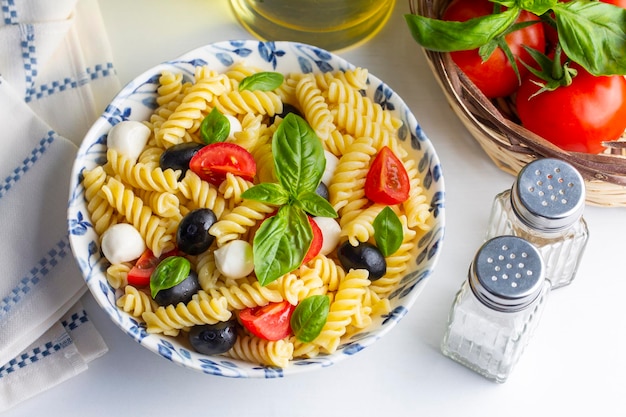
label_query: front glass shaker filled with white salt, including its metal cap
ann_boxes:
[441,236,550,383]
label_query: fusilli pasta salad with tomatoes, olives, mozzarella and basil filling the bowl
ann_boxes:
[82,62,431,367]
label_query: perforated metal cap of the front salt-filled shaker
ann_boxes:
[469,236,544,312]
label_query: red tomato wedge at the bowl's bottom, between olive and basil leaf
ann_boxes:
[239,301,295,340]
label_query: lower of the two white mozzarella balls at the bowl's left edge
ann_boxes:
[102,223,146,264]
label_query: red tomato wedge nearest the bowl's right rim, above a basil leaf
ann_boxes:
[365,146,411,205]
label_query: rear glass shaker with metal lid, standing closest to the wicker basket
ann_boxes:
[486,158,589,289]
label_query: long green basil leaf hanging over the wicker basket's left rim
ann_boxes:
[404,7,520,52]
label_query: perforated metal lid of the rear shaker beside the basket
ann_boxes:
[511,158,585,232]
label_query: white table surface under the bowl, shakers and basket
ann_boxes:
[5,0,626,417]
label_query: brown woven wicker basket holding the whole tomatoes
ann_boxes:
[409,0,626,207]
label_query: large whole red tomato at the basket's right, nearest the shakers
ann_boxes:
[516,65,626,153]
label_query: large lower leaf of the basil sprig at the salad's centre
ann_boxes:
[252,205,313,286]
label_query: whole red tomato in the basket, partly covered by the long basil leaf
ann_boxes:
[443,0,546,98]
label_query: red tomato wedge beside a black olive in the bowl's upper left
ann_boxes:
[189,142,256,186]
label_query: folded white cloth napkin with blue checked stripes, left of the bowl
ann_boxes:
[0,0,120,411]
